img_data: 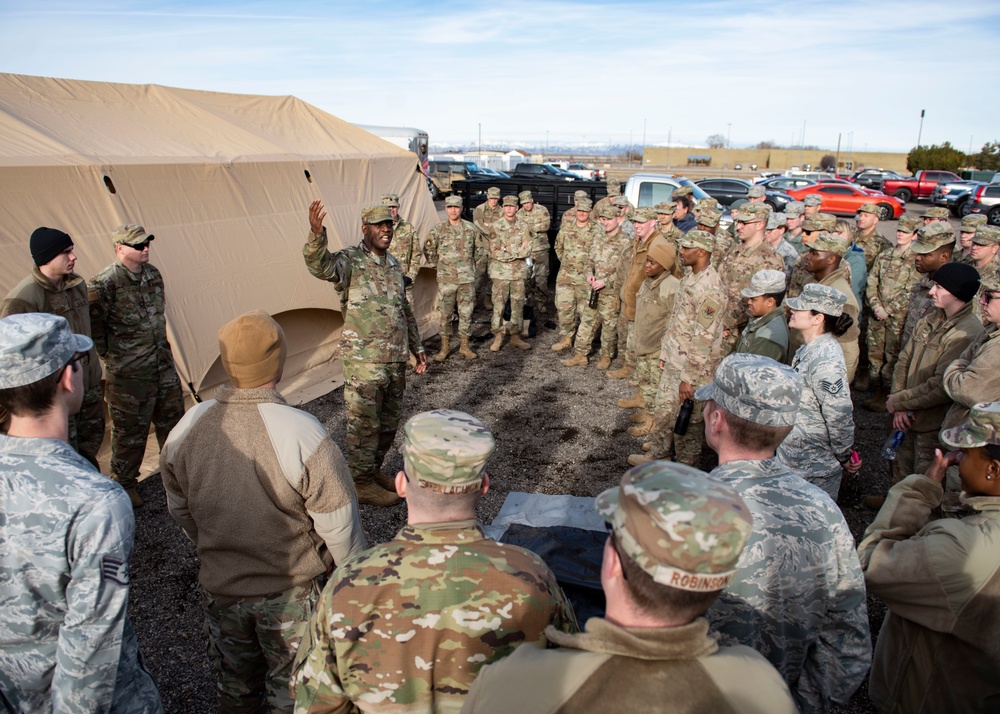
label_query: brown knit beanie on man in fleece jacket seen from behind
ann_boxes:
[219,309,288,389]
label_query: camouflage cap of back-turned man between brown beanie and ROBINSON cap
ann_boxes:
[402,409,496,493]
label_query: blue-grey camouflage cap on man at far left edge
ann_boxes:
[0,312,94,389]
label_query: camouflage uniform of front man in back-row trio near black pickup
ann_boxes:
[490,210,532,335]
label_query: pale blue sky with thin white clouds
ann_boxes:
[0,0,1000,151]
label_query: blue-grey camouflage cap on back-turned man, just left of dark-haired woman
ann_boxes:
[694,352,805,426]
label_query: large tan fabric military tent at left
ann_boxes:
[0,74,437,403]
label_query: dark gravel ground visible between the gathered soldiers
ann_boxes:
[130,294,889,713]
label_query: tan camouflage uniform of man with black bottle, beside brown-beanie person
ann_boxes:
[649,231,726,466]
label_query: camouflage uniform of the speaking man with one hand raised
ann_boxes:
[302,210,424,484]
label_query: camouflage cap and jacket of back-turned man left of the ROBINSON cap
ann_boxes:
[292,410,577,712]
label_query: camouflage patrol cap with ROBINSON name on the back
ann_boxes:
[596,461,753,592]
